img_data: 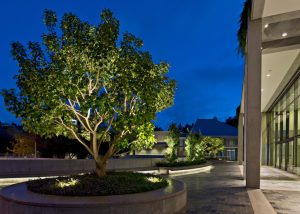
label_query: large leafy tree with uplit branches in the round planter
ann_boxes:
[2,10,175,176]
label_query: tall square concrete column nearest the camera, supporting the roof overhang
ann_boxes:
[244,19,262,189]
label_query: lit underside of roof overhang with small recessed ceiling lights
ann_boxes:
[246,0,300,113]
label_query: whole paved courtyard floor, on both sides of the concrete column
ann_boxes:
[0,162,300,214]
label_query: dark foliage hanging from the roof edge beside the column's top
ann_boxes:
[237,0,252,56]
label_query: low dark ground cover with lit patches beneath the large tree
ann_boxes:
[27,172,168,196]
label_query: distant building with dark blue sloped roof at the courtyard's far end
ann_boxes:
[192,118,238,161]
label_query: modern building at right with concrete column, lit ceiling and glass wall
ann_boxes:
[238,0,300,188]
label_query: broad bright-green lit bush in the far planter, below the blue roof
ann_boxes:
[185,133,224,161]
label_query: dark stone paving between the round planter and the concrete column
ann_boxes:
[174,162,253,214]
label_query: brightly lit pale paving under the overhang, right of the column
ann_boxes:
[261,166,300,214]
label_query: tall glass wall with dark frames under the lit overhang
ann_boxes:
[267,78,300,175]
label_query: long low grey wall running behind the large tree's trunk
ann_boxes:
[0,158,162,178]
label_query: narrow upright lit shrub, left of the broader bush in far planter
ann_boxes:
[166,123,180,163]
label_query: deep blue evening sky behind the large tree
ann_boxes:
[0,0,243,128]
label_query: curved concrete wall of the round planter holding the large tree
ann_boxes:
[0,179,186,214]
